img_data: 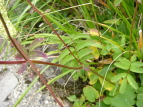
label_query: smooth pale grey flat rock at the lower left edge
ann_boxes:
[0,71,18,103]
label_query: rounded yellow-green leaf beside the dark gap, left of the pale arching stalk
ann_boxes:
[83,86,99,102]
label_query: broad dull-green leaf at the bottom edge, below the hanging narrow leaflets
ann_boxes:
[111,85,136,107]
